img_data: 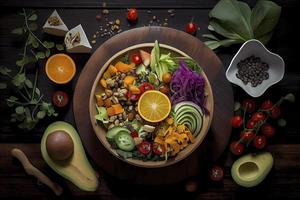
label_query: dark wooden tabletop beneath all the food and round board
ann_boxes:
[0,0,300,199]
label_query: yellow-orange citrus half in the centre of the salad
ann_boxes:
[138,90,171,122]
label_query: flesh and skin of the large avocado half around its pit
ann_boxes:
[41,121,98,191]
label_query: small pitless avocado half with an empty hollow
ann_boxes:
[231,152,273,187]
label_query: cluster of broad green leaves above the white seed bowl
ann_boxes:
[203,0,281,49]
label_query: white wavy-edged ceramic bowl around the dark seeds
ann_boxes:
[226,39,284,97]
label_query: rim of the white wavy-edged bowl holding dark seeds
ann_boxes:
[226,39,285,97]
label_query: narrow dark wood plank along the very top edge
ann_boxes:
[0,0,298,9]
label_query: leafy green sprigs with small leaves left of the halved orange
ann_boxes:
[0,9,64,130]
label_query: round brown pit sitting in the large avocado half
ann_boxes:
[46,130,74,160]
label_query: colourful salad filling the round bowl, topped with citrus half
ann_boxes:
[95,41,208,161]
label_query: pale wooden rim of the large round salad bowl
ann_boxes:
[89,42,214,168]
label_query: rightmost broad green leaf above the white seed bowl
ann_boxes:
[251,1,281,38]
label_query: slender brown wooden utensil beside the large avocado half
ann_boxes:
[11,148,63,196]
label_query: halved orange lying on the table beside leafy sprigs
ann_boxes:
[45,53,76,84]
